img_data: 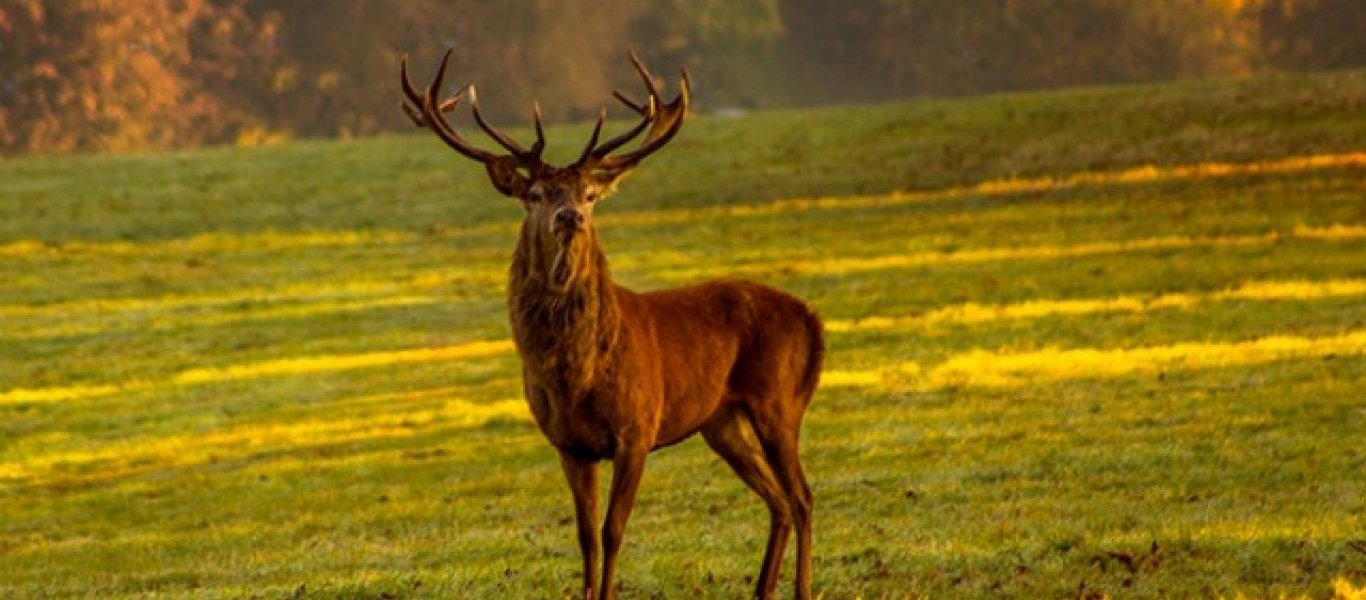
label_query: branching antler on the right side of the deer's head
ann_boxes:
[574,49,691,171]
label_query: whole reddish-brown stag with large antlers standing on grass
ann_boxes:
[400,51,825,600]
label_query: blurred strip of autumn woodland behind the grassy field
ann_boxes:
[0,0,1366,154]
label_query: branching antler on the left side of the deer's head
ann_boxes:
[399,49,545,168]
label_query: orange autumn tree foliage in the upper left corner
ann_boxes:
[0,0,270,152]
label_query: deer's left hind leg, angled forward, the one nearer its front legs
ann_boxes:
[702,409,792,599]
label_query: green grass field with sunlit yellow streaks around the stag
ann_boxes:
[8,71,1366,599]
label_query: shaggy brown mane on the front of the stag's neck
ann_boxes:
[508,228,622,400]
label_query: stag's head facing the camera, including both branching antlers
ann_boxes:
[400,51,688,288]
